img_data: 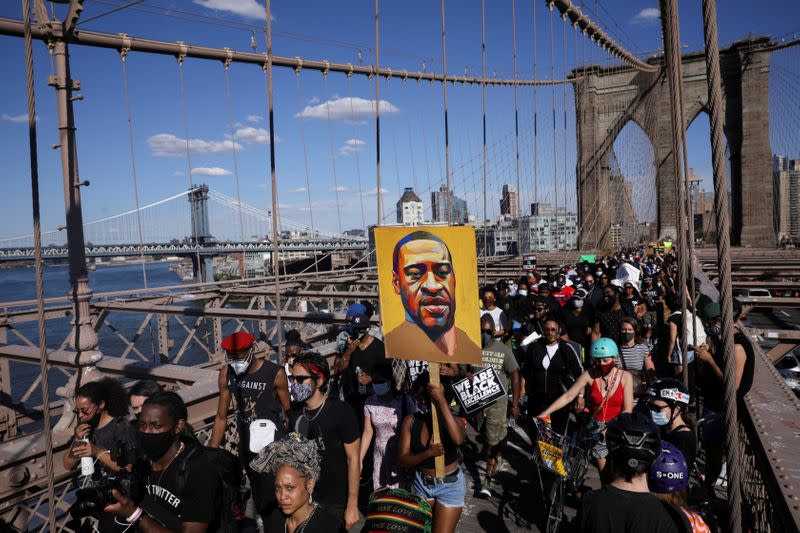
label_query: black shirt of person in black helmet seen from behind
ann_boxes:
[578,485,692,533]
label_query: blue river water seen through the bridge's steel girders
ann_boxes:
[0,262,206,406]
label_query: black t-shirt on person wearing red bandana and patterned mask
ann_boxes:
[289,400,358,506]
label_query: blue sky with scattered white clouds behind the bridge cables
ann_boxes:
[0,0,800,238]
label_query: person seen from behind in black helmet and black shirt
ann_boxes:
[578,413,692,533]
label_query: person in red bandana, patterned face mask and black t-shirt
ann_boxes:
[289,352,360,531]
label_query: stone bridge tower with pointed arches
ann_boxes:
[572,37,776,249]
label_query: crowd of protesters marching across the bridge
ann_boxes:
[64,251,754,533]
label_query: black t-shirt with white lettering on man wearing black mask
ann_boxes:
[140,443,221,531]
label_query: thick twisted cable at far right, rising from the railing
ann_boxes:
[703,0,743,531]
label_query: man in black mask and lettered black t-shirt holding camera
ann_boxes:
[105,392,222,533]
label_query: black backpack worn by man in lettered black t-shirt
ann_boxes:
[177,443,249,533]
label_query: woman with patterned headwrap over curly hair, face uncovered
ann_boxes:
[250,433,339,533]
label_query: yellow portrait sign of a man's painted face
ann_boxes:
[375,222,481,364]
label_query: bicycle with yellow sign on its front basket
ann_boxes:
[532,418,589,533]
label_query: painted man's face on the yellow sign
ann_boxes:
[392,239,456,340]
